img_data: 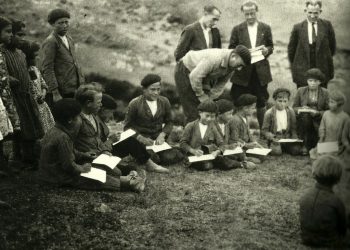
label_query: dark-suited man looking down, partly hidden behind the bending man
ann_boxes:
[174,5,221,61]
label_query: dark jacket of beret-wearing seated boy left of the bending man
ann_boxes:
[124,95,173,140]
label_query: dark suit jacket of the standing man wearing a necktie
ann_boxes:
[288,19,336,86]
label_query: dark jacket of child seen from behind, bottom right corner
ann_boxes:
[300,183,346,246]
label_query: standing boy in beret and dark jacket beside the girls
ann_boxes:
[40,9,84,106]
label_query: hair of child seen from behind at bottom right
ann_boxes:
[312,155,342,186]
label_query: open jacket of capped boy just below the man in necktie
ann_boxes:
[293,87,329,116]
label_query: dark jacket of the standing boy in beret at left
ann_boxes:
[40,32,84,94]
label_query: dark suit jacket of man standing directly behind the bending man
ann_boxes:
[174,21,221,61]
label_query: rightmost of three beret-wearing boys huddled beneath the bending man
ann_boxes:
[225,94,262,164]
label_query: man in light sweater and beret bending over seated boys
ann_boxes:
[175,45,251,122]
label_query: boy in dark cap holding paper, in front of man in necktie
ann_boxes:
[293,68,329,155]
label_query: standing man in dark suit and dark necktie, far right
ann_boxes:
[288,0,336,88]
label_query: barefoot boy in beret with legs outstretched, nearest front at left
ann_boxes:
[39,98,145,192]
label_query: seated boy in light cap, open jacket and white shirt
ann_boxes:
[261,88,301,155]
